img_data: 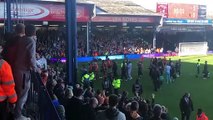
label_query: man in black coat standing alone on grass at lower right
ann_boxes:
[179,93,194,120]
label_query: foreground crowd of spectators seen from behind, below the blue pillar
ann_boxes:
[47,80,171,120]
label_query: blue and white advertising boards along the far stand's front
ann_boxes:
[51,53,177,63]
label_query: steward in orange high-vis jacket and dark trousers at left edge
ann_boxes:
[0,58,17,120]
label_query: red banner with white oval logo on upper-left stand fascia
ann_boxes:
[0,2,90,22]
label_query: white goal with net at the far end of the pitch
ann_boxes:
[178,42,208,56]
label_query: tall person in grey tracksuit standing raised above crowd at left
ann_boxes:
[13,25,38,120]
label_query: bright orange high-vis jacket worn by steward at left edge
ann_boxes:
[0,59,17,103]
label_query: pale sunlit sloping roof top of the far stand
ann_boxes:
[77,0,160,16]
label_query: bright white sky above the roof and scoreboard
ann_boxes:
[131,0,213,14]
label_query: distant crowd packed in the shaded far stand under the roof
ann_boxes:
[37,28,152,59]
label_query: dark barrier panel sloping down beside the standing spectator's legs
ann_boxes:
[28,73,61,120]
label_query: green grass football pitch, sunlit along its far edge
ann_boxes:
[79,55,213,120]
